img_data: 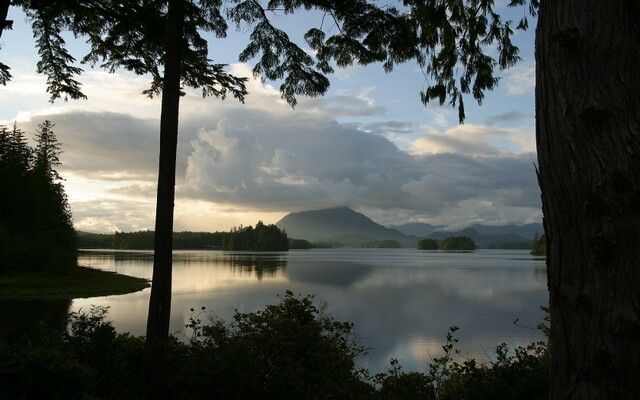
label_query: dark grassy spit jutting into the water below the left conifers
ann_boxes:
[0,267,149,300]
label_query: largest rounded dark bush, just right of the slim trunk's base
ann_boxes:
[188,291,372,399]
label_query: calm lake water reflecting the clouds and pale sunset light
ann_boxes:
[0,249,548,373]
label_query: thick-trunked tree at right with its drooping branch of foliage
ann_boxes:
[314,0,640,399]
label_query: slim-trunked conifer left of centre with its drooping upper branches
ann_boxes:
[3,0,397,341]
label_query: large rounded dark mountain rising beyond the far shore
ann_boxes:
[276,207,418,247]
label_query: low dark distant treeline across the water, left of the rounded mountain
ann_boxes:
[78,221,292,251]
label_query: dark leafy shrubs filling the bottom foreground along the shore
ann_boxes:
[0,292,549,400]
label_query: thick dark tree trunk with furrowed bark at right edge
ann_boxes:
[536,0,640,399]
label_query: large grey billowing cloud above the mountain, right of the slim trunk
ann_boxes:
[179,106,539,223]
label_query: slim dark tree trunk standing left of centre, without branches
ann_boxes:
[147,0,184,344]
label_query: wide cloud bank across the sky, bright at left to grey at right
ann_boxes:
[6,65,540,231]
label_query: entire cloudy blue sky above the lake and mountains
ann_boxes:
[0,1,542,233]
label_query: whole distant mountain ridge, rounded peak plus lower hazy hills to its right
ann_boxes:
[276,207,543,248]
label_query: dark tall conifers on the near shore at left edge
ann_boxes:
[0,120,77,272]
